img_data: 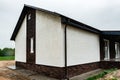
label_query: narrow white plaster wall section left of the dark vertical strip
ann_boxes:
[15,17,26,62]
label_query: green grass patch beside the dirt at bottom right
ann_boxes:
[86,68,117,80]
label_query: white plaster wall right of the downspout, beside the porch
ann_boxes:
[67,26,100,66]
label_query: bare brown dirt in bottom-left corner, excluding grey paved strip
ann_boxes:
[0,61,30,80]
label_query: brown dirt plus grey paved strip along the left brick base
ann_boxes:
[0,61,57,80]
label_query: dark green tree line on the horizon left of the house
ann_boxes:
[0,48,15,56]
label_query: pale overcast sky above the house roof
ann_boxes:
[0,0,120,48]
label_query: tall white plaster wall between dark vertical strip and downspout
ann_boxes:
[36,11,64,67]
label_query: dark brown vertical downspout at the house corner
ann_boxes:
[64,24,69,80]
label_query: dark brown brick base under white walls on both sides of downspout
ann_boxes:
[16,61,99,79]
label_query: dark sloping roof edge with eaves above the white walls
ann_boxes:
[11,5,109,40]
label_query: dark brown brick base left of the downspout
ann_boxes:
[16,61,65,79]
